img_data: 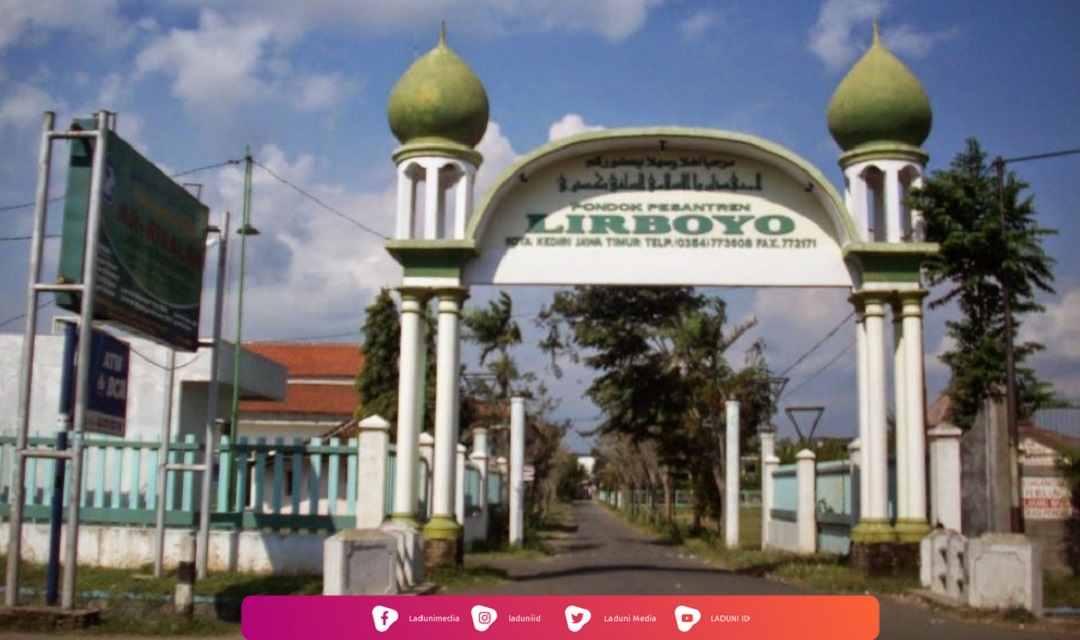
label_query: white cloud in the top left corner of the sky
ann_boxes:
[0,0,133,51]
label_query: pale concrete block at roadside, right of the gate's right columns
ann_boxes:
[964,533,1042,615]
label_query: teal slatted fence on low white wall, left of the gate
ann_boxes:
[0,434,502,532]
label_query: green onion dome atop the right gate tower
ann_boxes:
[828,19,933,152]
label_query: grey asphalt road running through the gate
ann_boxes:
[454,502,1080,640]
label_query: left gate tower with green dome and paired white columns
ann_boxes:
[387,25,489,584]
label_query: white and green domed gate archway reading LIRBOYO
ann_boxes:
[386,27,936,569]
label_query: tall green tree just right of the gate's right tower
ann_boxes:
[907,139,1055,428]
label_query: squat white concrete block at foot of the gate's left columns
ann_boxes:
[323,529,399,596]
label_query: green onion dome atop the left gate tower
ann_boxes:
[387,23,489,149]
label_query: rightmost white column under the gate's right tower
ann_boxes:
[897,291,933,542]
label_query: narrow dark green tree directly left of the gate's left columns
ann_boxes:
[354,289,401,422]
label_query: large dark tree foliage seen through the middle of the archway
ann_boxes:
[540,287,768,518]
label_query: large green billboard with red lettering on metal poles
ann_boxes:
[57,120,210,351]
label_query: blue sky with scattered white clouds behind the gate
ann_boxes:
[0,0,1080,448]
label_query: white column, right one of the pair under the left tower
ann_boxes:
[424,289,464,531]
